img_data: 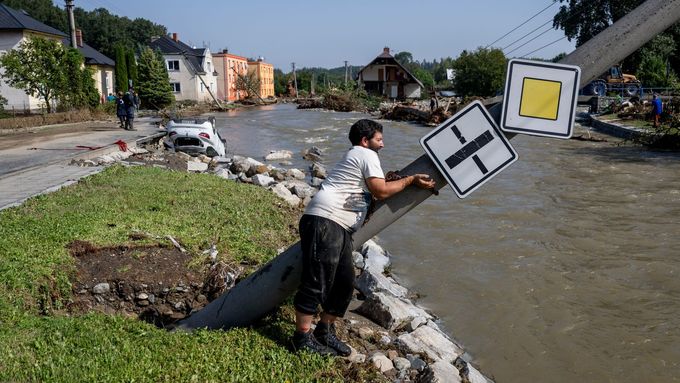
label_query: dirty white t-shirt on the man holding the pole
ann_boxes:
[305,146,385,232]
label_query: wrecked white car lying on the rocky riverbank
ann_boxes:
[165,117,227,157]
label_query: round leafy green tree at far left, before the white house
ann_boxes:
[0,37,66,113]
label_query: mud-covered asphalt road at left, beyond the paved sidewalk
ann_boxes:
[0,117,158,177]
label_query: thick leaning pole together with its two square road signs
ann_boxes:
[176,0,680,330]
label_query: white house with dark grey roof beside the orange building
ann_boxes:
[149,33,218,102]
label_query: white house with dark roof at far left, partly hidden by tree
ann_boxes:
[0,4,66,111]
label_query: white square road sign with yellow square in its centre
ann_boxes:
[501,59,581,138]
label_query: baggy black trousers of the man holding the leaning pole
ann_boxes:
[294,215,354,317]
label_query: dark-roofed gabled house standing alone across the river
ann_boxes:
[356,47,424,99]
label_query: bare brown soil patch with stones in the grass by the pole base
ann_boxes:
[68,241,240,327]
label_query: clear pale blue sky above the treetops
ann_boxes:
[62,0,575,72]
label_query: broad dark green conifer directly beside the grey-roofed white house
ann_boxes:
[137,47,175,109]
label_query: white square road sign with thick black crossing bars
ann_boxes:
[420,101,517,198]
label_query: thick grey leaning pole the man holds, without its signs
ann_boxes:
[177,0,680,330]
